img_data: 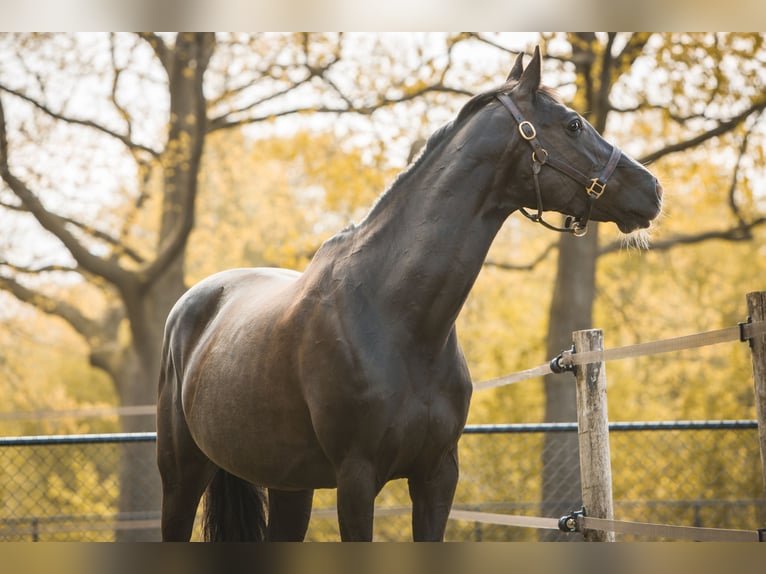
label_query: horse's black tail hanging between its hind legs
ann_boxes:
[202,468,266,542]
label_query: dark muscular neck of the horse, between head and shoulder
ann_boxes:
[349,129,513,342]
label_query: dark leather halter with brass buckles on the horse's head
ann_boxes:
[497,94,622,237]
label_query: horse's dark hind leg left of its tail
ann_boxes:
[157,380,217,542]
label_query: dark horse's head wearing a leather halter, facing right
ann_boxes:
[494,48,662,235]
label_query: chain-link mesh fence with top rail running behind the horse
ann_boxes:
[0,421,766,541]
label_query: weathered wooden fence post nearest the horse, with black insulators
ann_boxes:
[572,329,614,542]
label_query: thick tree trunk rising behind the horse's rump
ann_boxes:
[108,33,215,541]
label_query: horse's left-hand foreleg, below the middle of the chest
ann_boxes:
[337,459,379,542]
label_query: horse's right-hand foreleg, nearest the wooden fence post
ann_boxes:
[409,446,458,542]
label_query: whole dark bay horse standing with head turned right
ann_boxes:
[157,50,662,540]
